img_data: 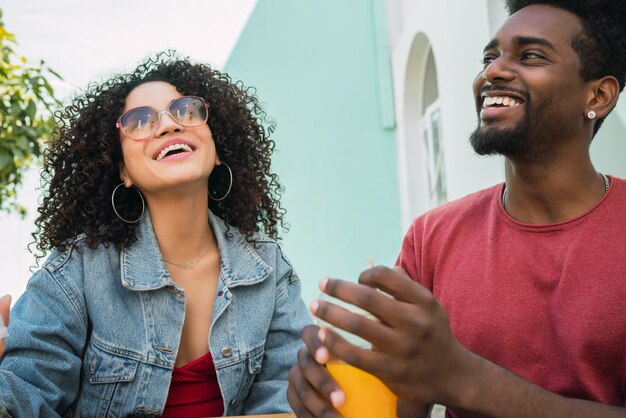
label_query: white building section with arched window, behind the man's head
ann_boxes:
[385,0,626,227]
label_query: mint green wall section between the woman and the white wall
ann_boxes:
[225,0,403,301]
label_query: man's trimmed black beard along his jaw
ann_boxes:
[470,100,555,164]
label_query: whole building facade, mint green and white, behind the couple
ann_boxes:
[226,0,626,300]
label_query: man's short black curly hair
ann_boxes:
[506,0,626,134]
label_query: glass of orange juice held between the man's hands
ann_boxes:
[317,293,398,418]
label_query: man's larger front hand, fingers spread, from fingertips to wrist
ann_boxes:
[307,267,476,405]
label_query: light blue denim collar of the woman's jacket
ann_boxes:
[120,211,272,291]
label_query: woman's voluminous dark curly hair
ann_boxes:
[33,51,287,252]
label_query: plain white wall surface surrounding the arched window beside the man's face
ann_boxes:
[387,0,503,228]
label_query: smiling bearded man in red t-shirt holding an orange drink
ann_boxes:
[287,0,626,417]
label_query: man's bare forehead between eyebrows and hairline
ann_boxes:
[490,4,583,47]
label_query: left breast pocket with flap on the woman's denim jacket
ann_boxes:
[74,337,139,417]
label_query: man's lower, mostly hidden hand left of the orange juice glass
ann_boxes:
[287,325,345,418]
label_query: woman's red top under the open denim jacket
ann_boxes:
[161,352,224,418]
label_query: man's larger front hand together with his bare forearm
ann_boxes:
[309,267,625,418]
